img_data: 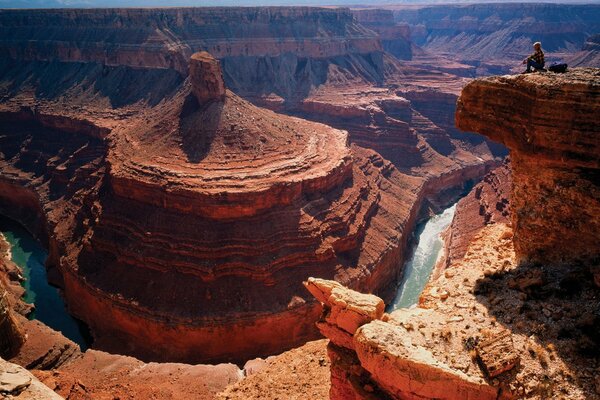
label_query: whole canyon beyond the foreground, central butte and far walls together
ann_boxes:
[0,4,600,398]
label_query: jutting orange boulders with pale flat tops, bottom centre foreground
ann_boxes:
[305,278,499,399]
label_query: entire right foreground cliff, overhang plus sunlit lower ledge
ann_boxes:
[305,68,600,399]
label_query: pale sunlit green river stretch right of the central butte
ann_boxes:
[388,204,456,311]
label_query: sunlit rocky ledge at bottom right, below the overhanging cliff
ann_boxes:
[307,219,600,400]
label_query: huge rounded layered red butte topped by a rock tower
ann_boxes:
[1,51,423,361]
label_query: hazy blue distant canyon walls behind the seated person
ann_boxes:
[390,4,600,75]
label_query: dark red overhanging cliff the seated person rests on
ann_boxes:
[456,69,600,263]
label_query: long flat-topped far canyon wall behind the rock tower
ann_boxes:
[0,7,383,100]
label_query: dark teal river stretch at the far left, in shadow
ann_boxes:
[0,216,91,350]
